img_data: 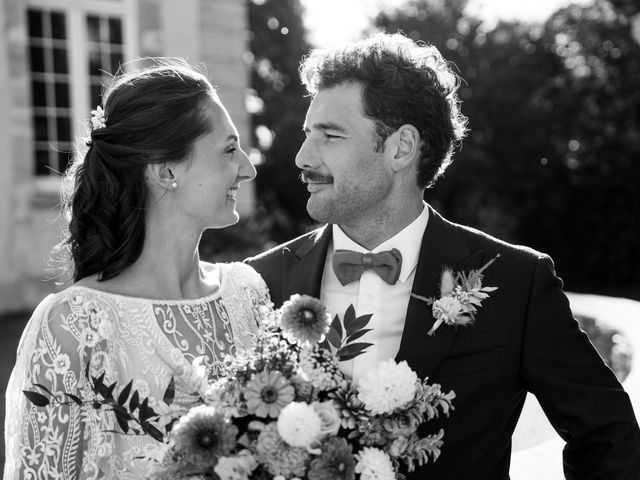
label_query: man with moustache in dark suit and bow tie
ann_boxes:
[242,34,640,480]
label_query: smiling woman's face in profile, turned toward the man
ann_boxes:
[174,101,256,230]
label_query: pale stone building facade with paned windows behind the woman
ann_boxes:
[0,0,255,314]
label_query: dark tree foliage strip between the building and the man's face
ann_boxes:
[249,0,310,240]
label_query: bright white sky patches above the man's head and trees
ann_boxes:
[301,0,589,47]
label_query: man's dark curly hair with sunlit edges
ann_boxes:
[300,33,467,188]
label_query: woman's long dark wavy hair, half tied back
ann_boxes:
[58,59,217,281]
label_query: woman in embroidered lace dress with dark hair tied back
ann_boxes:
[4,60,269,480]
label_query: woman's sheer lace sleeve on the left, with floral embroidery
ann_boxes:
[4,294,114,480]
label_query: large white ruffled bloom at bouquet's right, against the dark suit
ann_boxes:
[358,359,418,414]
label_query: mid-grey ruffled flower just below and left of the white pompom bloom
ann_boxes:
[256,422,309,477]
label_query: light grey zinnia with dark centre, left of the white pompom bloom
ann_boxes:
[244,371,295,418]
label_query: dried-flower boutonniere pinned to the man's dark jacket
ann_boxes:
[411,254,500,335]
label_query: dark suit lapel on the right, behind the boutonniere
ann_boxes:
[396,207,483,378]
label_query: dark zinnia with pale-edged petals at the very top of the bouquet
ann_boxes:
[280,295,331,343]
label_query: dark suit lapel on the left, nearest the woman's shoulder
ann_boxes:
[282,225,331,302]
